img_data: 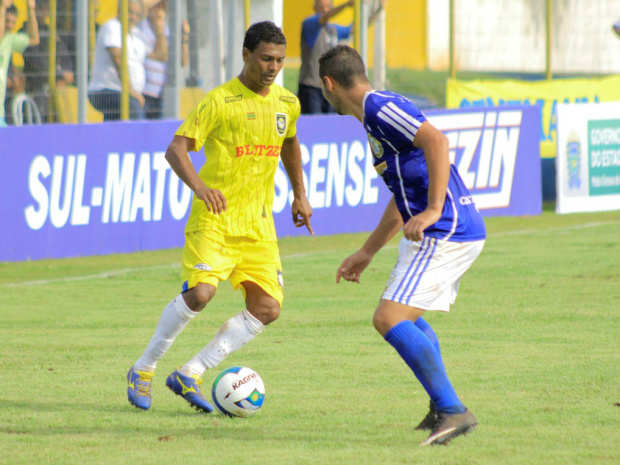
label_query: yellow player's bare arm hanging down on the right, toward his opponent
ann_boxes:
[280,136,314,234]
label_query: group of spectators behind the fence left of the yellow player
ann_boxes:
[0,0,190,126]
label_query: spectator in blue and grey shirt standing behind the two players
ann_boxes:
[297,0,387,114]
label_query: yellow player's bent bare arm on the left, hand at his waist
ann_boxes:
[166,136,226,215]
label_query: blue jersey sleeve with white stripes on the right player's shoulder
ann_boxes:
[368,98,426,148]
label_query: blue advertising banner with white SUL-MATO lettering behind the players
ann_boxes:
[0,107,541,261]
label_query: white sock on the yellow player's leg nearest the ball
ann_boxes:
[180,310,265,376]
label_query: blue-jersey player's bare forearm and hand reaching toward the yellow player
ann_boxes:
[336,197,403,283]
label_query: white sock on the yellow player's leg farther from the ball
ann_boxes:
[134,294,198,371]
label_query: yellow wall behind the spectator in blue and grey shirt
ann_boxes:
[282,0,427,69]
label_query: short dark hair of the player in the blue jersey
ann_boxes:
[319,45,368,89]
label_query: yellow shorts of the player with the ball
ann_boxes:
[181,231,284,307]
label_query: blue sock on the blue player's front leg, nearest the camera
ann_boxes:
[385,320,465,413]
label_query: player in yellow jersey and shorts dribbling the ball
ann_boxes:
[127,21,313,413]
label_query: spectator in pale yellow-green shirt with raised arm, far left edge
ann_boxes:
[0,0,39,127]
